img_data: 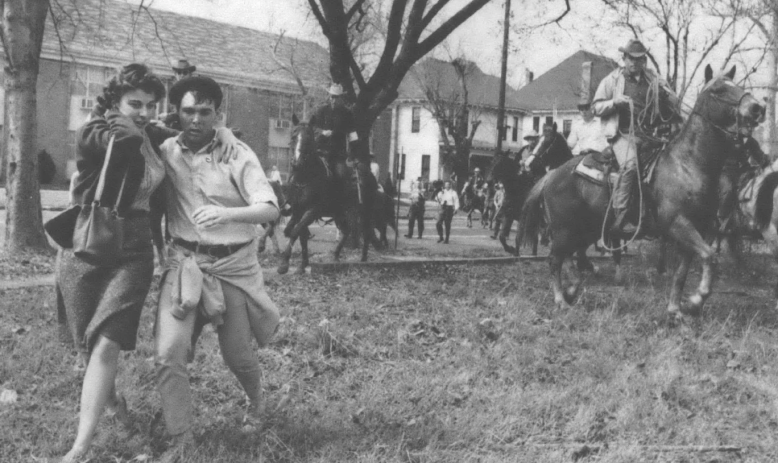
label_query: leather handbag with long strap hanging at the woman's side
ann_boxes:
[73,136,127,264]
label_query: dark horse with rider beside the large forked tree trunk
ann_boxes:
[277,116,378,274]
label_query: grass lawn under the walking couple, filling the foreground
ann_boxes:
[0,244,778,463]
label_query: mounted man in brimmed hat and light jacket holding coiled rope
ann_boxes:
[592,39,679,237]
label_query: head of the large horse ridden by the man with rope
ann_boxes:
[694,65,765,138]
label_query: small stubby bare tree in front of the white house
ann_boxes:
[411,56,482,183]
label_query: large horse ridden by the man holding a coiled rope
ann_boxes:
[518,66,765,317]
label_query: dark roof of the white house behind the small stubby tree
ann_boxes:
[397,58,522,111]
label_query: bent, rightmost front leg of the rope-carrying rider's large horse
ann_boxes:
[670,216,716,316]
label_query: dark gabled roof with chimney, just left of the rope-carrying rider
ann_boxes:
[515,50,618,111]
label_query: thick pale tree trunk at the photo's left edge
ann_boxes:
[2,0,49,254]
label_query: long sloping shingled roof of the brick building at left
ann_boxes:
[42,0,329,92]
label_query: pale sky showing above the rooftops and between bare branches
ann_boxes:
[130,0,768,94]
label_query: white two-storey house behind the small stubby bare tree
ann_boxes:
[388,58,526,191]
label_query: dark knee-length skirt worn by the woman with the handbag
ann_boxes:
[56,215,154,352]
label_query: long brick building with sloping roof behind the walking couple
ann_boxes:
[0,0,329,185]
